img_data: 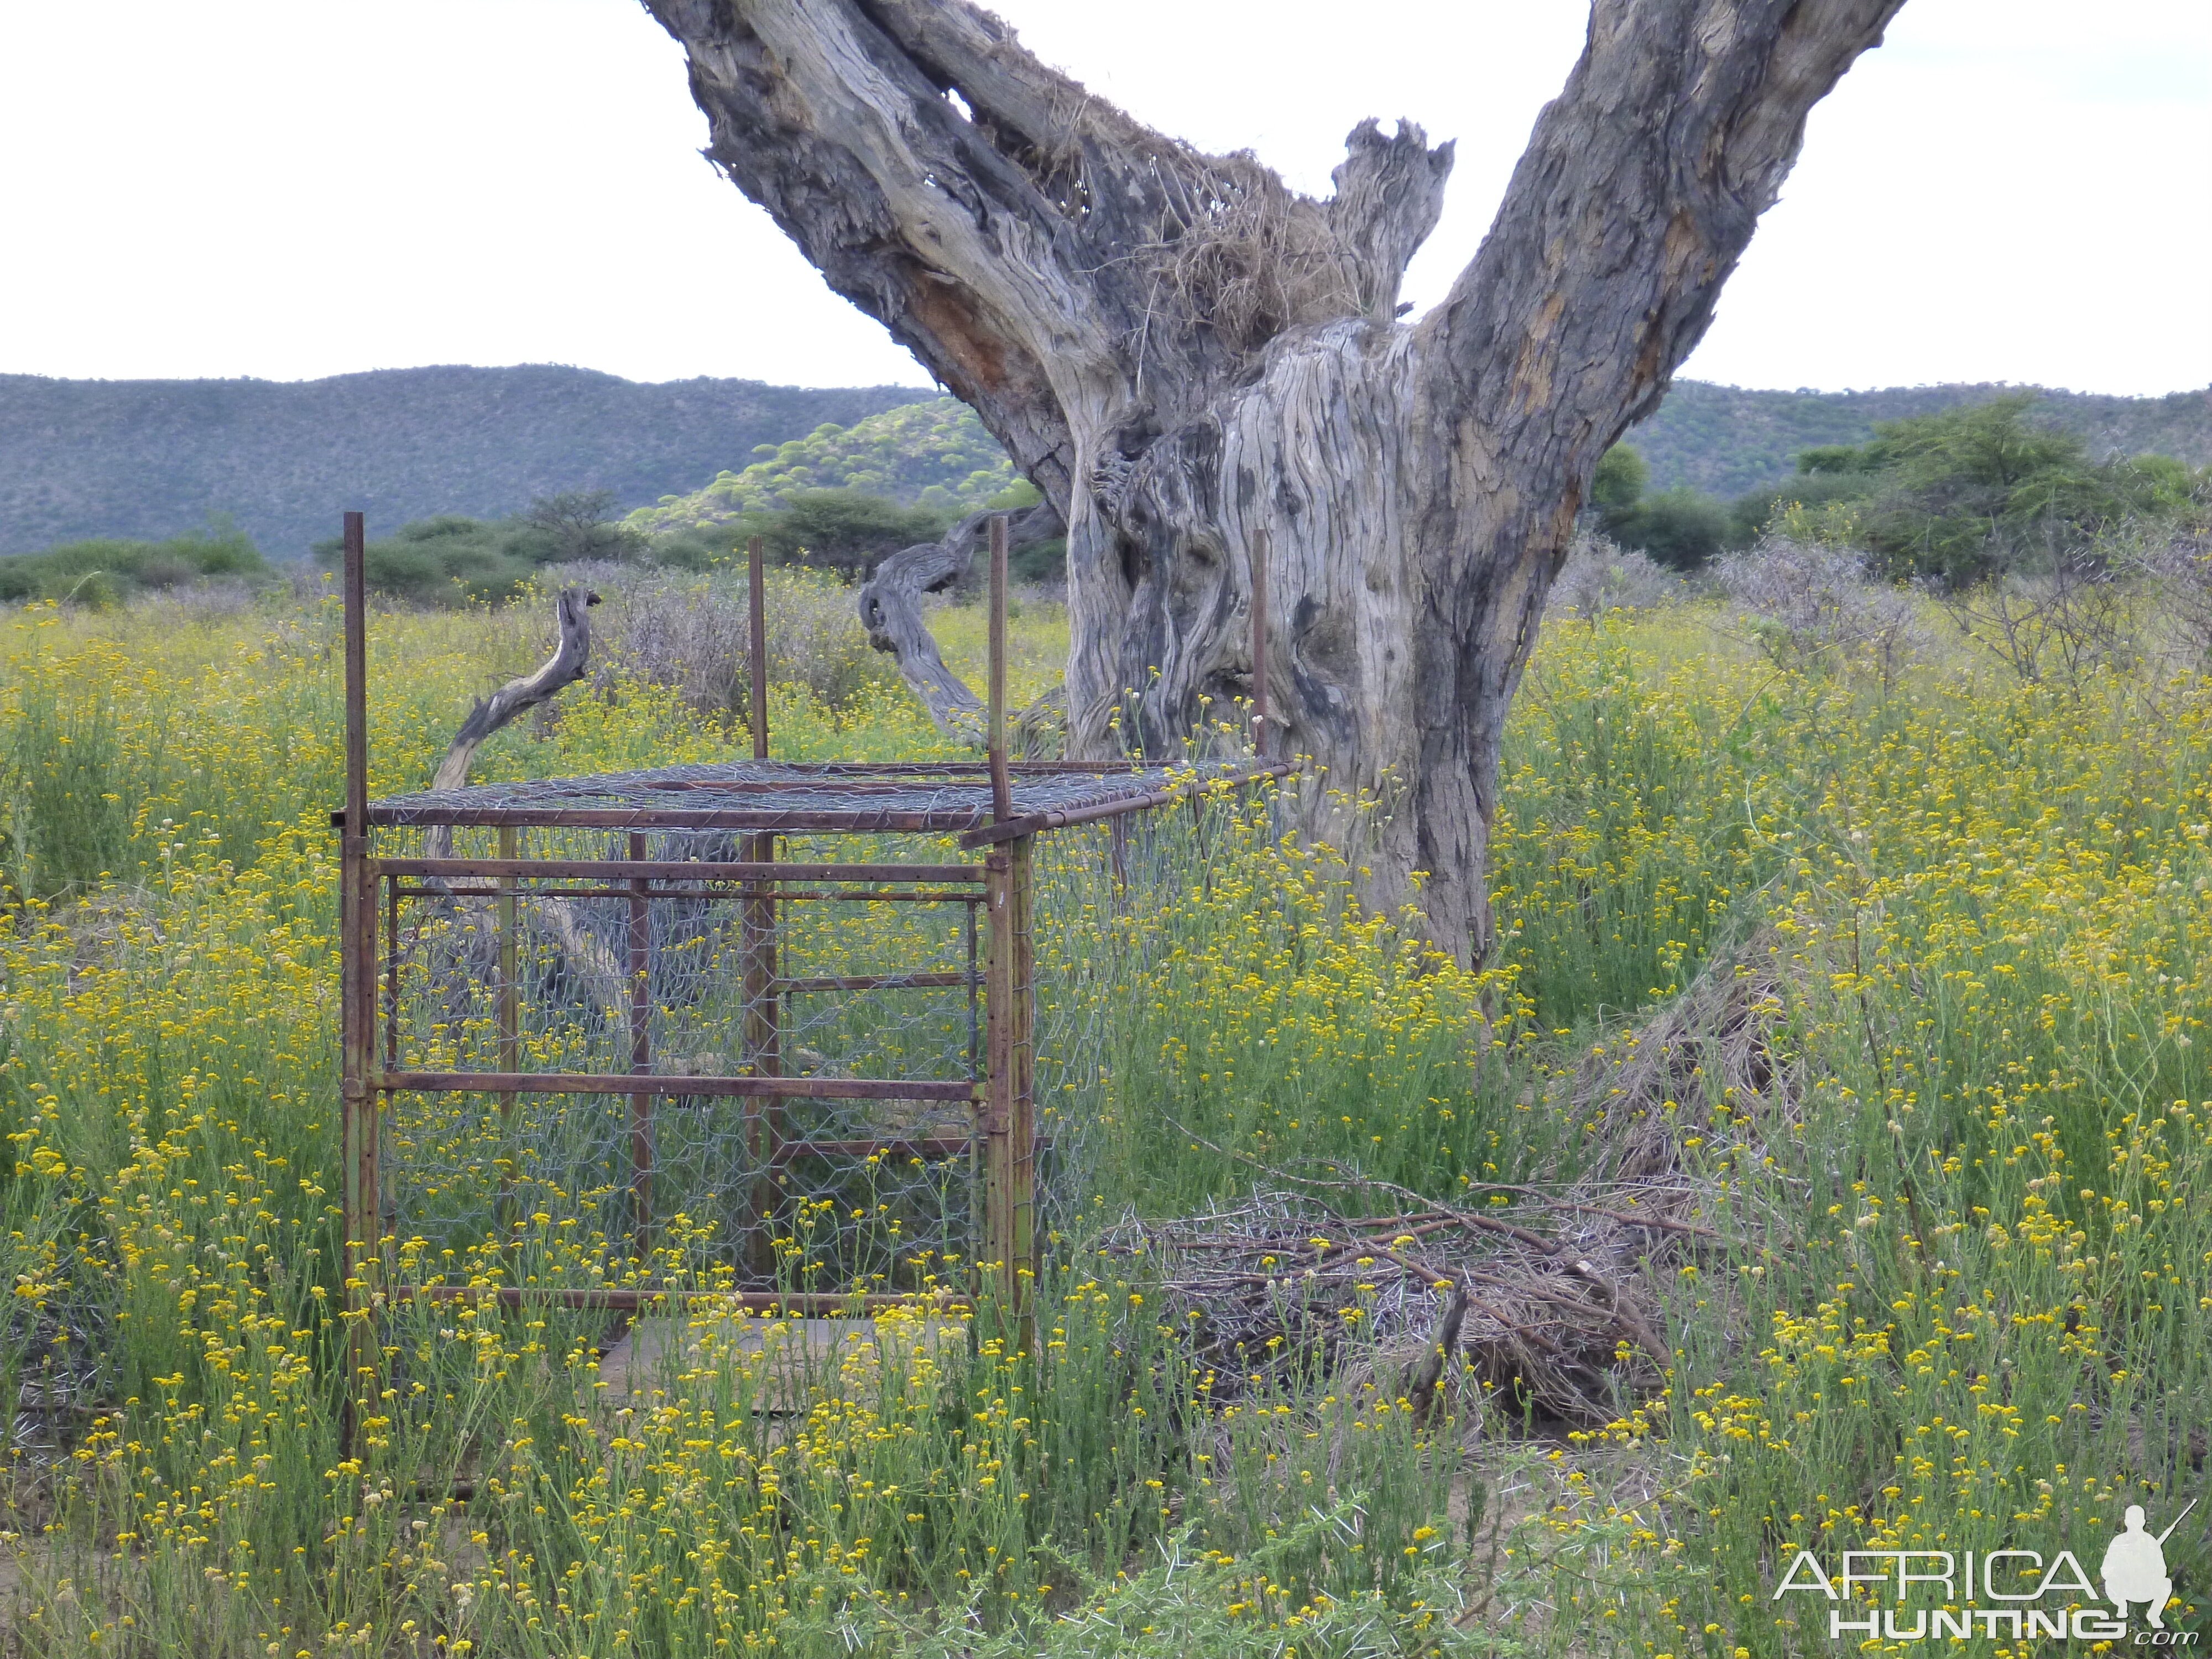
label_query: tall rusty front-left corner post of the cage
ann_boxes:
[338,513,378,1458]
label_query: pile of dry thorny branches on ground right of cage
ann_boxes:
[1102,942,1801,1425]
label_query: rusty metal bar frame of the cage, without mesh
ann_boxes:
[332,513,1298,1451]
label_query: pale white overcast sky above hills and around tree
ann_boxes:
[0,0,2212,394]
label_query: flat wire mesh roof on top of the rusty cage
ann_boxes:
[369,761,1283,834]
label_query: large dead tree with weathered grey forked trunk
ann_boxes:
[644,0,1902,960]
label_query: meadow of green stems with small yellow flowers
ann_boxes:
[0,593,2212,1659]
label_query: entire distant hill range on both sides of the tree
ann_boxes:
[0,365,2212,560]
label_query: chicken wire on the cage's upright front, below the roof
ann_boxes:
[380,827,984,1290]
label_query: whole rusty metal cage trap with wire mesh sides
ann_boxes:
[332,513,1292,1389]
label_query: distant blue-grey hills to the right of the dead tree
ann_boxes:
[1628,380,2212,495]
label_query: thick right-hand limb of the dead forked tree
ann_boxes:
[1422,0,1905,449]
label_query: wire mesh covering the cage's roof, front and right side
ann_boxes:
[354,763,1292,1292]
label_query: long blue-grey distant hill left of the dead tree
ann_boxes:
[0,365,933,557]
